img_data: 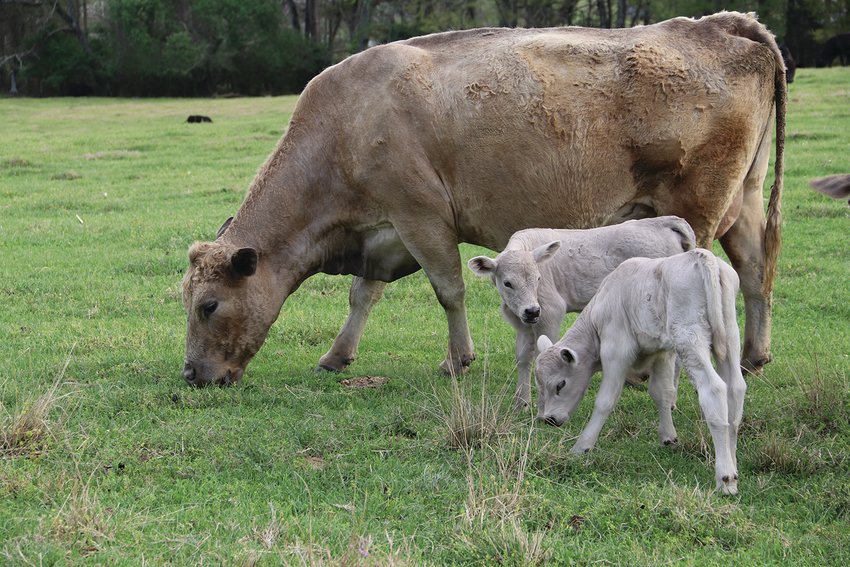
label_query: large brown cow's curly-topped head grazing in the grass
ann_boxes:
[183,226,280,386]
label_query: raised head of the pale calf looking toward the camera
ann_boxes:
[467,240,561,325]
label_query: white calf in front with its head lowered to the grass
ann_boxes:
[537,249,747,494]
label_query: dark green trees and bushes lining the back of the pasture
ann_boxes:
[0,0,850,96]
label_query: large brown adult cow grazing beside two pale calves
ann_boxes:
[183,12,785,385]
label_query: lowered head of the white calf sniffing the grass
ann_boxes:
[535,335,594,427]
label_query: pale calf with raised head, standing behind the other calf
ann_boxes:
[468,216,696,407]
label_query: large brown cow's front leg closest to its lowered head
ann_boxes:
[319,276,387,372]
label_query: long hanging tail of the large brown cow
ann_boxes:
[707,12,788,297]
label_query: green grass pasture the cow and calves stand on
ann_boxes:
[0,68,850,565]
